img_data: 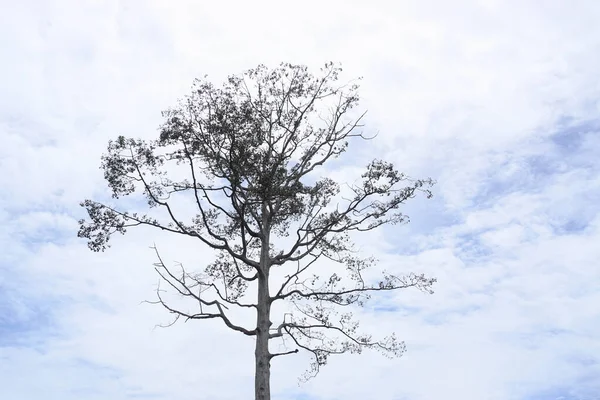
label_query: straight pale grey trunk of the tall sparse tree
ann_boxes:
[254,214,271,400]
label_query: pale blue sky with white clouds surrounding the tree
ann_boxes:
[0,0,600,400]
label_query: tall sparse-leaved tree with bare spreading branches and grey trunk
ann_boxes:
[78,63,435,400]
